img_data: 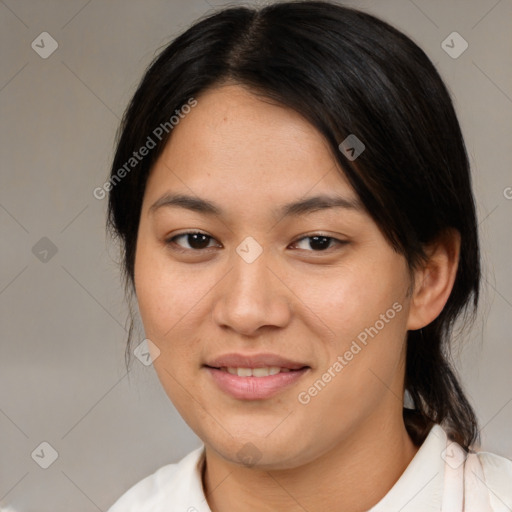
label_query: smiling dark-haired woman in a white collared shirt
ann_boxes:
[108,2,512,512]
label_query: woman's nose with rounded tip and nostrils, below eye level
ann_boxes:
[213,247,292,337]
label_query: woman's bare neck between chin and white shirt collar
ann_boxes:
[203,415,418,512]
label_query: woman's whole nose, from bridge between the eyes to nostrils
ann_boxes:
[214,237,289,334]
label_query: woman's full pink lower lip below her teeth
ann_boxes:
[205,367,309,400]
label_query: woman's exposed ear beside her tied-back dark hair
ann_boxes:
[407,229,460,331]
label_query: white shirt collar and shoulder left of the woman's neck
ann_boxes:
[107,446,204,512]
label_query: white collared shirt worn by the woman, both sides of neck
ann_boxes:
[108,425,512,512]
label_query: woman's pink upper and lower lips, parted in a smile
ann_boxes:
[204,354,310,400]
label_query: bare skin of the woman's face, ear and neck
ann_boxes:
[135,85,458,512]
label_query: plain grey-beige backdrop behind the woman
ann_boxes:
[0,0,512,512]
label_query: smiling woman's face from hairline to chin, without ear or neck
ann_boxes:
[135,85,411,468]
